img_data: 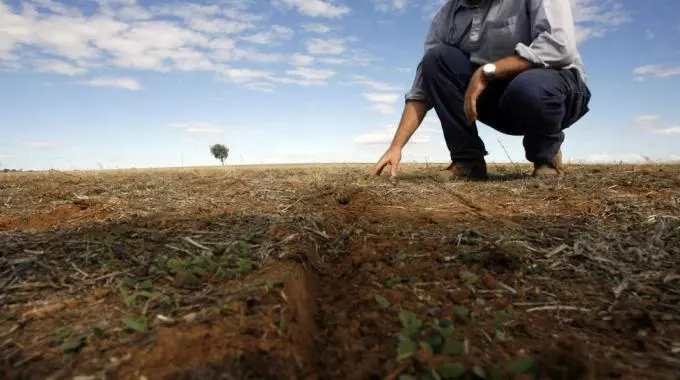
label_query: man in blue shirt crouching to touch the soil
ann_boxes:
[373,0,591,179]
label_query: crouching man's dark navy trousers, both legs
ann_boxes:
[421,45,590,164]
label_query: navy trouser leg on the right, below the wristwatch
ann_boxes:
[499,69,590,165]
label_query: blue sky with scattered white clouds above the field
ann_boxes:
[0,0,680,169]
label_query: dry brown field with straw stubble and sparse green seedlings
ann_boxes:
[0,165,680,380]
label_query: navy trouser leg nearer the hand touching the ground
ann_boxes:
[421,45,487,161]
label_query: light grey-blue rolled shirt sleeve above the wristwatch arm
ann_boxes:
[515,0,577,68]
